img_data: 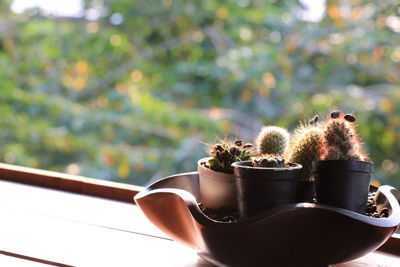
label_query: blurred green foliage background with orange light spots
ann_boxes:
[0,0,400,188]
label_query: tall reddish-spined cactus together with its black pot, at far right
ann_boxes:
[313,111,373,213]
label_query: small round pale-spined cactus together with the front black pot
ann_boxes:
[232,126,301,218]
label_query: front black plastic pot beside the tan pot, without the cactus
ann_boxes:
[232,161,302,218]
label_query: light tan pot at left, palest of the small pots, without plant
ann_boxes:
[197,158,237,210]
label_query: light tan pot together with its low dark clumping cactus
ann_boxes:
[197,140,253,210]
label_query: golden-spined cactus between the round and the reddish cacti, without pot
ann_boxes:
[287,115,323,181]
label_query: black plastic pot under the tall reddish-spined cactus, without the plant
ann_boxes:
[313,160,374,213]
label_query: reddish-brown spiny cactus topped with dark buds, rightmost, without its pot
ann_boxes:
[321,110,368,161]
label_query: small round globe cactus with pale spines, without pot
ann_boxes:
[255,126,289,155]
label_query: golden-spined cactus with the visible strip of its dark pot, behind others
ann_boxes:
[287,115,323,202]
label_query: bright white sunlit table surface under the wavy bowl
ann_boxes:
[0,181,400,267]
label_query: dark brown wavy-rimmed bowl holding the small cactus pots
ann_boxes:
[134,172,400,266]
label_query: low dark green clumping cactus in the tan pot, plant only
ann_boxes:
[205,140,253,173]
